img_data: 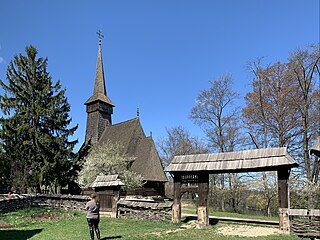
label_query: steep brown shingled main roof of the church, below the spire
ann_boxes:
[98,117,167,182]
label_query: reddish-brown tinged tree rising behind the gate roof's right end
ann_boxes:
[243,59,299,215]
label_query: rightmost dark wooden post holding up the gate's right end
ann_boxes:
[278,168,290,233]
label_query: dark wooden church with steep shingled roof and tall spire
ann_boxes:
[82,38,167,196]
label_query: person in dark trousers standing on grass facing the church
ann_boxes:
[86,193,100,240]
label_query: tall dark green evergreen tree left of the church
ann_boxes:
[0,46,77,192]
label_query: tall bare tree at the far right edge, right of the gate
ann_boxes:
[289,44,320,208]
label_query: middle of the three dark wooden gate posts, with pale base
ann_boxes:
[198,172,209,227]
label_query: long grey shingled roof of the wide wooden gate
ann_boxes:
[165,147,298,173]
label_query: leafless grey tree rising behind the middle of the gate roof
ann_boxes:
[190,74,239,211]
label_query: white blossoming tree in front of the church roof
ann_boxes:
[78,141,143,190]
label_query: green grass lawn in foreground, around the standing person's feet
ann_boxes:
[0,209,298,240]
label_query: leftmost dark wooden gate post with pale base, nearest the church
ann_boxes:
[172,173,181,223]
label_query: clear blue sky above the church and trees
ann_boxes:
[0,0,319,149]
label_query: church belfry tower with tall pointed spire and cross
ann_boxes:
[84,30,114,144]
